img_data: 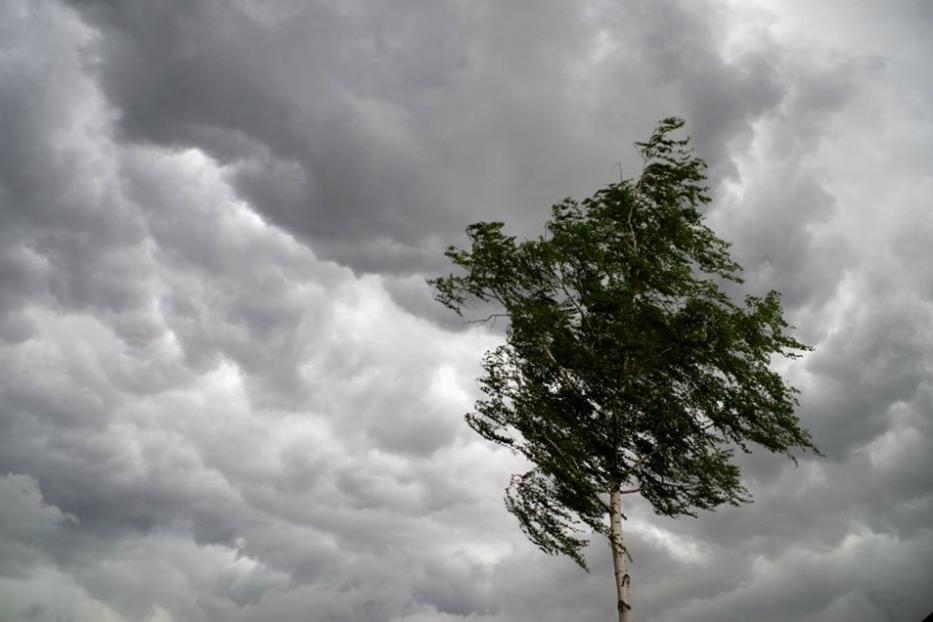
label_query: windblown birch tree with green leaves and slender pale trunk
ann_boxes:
[429,118,818,622]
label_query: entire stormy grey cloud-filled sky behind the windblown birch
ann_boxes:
[0,0,933,622]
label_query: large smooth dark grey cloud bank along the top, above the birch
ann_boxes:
[63,1,791,272]
